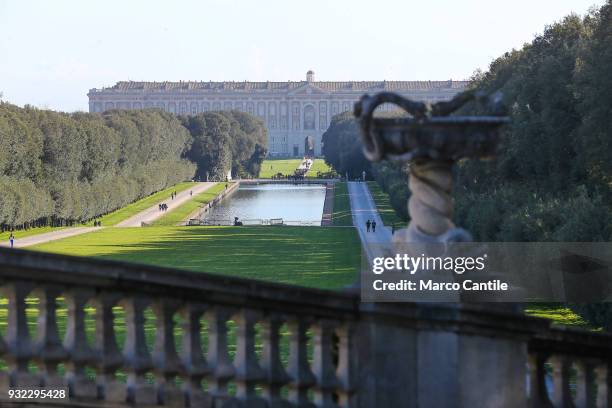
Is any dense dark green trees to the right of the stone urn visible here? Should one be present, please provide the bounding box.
[456,1,612,330]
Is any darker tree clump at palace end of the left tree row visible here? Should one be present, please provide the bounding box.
[181,111,267,180]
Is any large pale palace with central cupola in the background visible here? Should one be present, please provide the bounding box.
[87,71,467,156]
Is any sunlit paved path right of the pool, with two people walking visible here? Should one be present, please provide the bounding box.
[348,181,391,260]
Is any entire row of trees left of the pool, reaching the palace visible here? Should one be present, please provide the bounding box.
[0,103,266,230]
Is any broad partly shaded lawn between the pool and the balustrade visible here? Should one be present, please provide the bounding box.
[31,226,360,289]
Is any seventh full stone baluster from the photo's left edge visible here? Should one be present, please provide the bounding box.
[180,304,212,408]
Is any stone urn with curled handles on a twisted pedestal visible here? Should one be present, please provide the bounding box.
[354,90,509,243]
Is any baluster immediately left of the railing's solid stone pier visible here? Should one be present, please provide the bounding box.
[336,323,357,408]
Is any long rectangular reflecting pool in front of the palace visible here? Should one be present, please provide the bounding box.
[203,184,325,225]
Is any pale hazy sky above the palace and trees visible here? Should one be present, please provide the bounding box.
[0,0,604,112]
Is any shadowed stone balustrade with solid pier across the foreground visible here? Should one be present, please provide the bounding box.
[0,249,612,407]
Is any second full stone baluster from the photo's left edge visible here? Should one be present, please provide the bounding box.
[33,286,67,388]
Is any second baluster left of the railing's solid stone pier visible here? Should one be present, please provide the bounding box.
[312,320,340,408]
